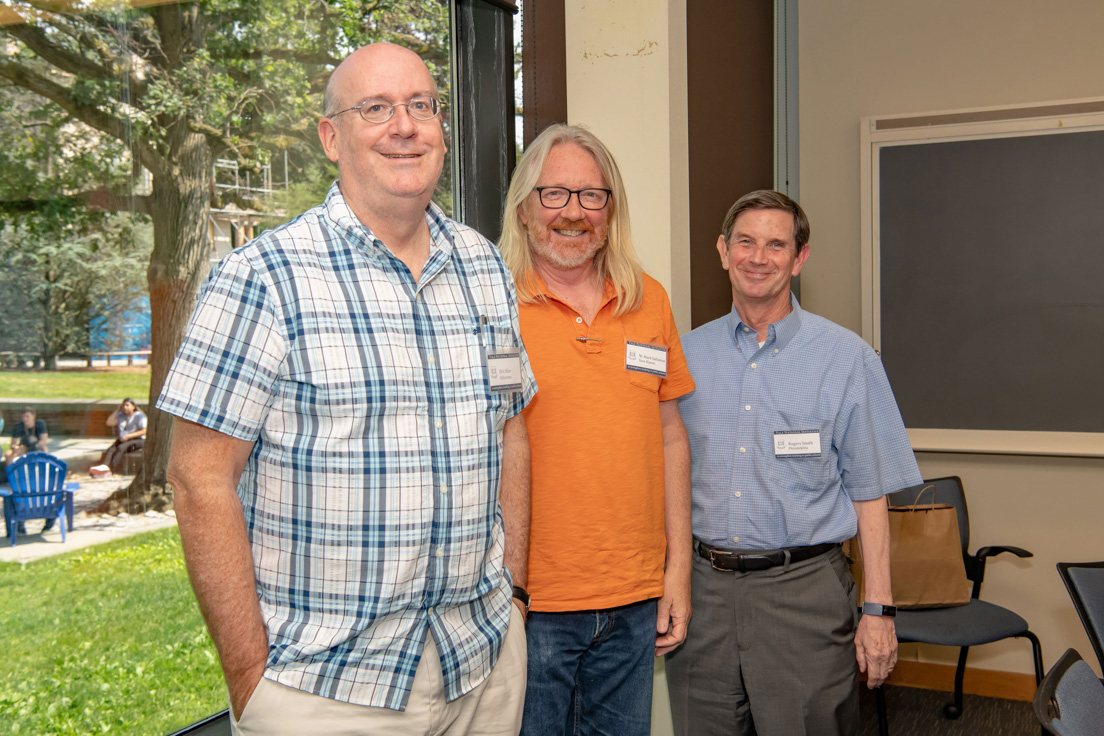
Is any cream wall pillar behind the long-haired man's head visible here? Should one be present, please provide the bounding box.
[564,0,690,331]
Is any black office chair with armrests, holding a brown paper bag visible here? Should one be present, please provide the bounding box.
[874,476,1043,736]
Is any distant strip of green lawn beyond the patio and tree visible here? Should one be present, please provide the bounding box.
[0,369,149,402]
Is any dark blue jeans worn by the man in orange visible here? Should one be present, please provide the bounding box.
[521,600,656,736]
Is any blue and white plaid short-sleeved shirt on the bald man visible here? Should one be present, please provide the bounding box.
[159,183,537,710]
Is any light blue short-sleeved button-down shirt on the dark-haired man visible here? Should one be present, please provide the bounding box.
[679,298,921,550]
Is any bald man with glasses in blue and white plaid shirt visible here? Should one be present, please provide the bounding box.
[159,44,537,734]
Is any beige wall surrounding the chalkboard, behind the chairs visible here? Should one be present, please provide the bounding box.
[798,0,1104,672]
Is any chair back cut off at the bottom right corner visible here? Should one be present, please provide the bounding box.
[1033,649,1104,736]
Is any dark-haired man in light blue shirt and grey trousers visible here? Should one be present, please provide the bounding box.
[667,191,921,736]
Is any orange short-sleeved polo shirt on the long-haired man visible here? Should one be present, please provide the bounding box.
[520,275,694,611]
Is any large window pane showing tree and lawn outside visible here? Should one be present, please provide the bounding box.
[0,0,456,734]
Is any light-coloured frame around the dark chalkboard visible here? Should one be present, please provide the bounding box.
[860,98,1104,457]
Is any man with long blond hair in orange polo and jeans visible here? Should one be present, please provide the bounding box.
[499,125,693,736]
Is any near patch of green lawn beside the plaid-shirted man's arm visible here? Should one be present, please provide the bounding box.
[0,527,226,735]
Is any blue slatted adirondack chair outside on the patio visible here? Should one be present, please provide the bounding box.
[3,452,73,546]
